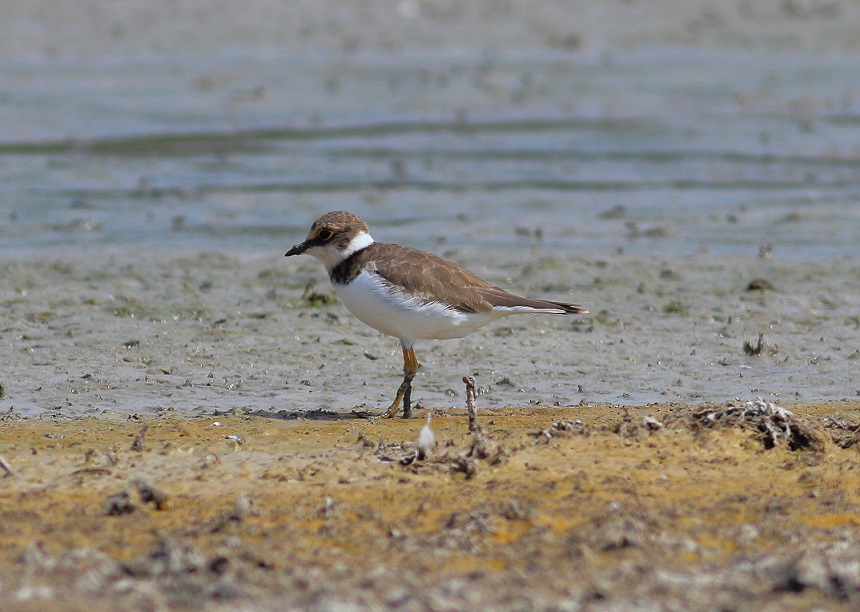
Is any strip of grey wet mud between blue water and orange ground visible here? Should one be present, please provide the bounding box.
[0,246,860,418]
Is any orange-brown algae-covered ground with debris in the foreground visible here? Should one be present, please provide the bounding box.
[0,402,860,610]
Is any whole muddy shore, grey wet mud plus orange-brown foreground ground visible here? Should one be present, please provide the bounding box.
[0,247,860,610]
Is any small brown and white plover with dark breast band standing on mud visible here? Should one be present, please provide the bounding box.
[286,210,588,419]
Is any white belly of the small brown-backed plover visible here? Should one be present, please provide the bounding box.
[335,272,506,340]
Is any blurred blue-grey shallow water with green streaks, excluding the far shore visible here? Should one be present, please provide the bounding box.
[0,51,860,259]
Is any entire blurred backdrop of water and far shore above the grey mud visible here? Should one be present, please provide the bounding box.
[0,0,860,259]
